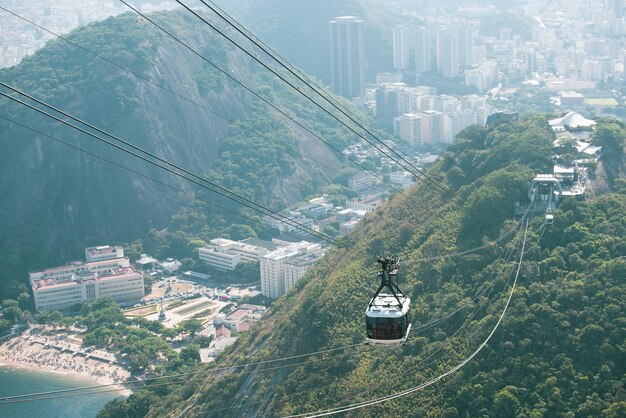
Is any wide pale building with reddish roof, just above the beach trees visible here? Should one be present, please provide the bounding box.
[29,248,145,311]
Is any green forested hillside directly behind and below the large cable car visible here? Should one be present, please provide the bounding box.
[96,118,626,417]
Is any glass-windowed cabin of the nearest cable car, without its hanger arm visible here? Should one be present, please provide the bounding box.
[365,293,411,345]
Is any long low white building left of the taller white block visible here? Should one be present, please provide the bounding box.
[198,238,269,271]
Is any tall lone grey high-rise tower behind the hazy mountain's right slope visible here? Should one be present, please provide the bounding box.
[329,16,365,98]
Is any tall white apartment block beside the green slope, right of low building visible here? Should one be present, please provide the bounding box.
[261,241,322,298]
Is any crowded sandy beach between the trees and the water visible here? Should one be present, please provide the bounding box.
[0,330,131,396]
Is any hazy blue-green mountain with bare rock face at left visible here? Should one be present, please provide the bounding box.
[0,12,352,297]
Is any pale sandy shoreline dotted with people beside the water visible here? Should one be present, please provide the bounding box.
[0,334,133,397]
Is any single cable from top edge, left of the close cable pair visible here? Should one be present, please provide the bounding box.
[119,0,404,198]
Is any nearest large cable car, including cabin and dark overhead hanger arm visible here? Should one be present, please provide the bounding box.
[365,257,411,345]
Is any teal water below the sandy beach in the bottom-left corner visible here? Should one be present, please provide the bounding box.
[0,366,122,418]
